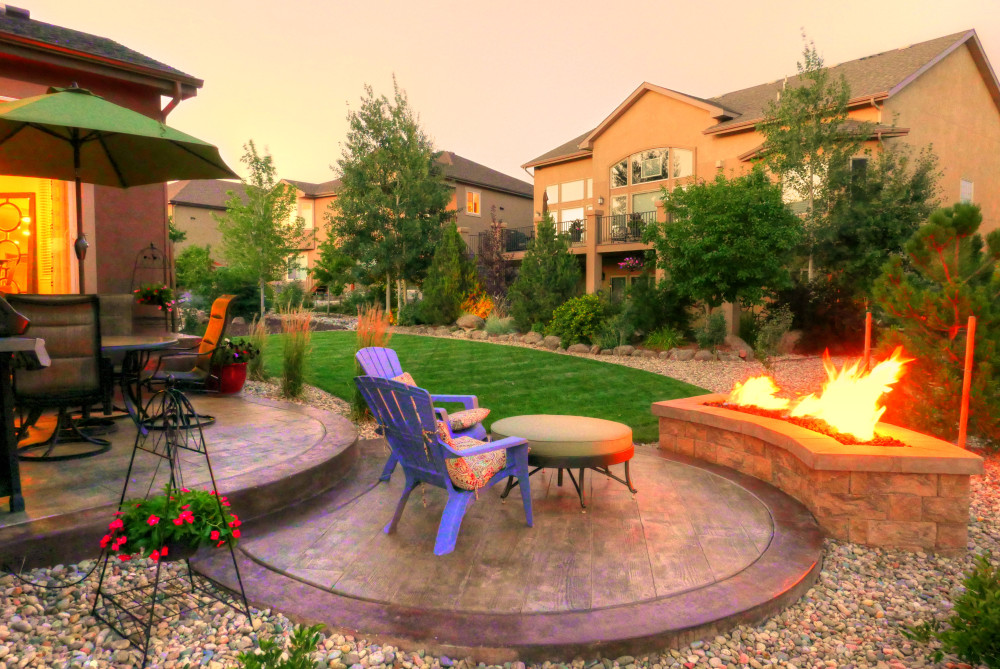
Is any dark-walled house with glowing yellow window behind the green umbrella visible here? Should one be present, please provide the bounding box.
[0,4,203,293]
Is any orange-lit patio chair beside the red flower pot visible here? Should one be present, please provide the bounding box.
[143,295,236,427]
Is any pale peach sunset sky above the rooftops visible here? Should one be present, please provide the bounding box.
[23,0,1000,182]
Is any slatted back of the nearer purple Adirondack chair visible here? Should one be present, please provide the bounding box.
[354,376,451,488]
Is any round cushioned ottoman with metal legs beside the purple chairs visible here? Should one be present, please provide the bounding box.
[491,414,636,508]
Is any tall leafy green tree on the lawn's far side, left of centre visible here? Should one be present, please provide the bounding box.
[326,79,455,311]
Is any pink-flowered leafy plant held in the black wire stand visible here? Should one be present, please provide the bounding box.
[101,486,242,562]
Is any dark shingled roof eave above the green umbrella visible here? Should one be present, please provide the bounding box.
[0,5,204,87]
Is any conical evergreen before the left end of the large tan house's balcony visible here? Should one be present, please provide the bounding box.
[507,214,580,330]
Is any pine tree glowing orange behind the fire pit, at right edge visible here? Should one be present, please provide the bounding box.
[875,204,1000,443]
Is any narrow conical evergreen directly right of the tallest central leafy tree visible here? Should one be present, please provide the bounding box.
[420,223,475,325]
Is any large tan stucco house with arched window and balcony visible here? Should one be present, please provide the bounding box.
[514,30,1000,292]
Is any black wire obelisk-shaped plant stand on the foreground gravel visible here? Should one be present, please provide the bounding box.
[92,385,251,667]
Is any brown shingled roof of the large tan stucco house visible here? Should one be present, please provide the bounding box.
[523,30,1000,167]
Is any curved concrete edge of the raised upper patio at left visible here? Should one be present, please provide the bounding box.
[0,397,358,570]
